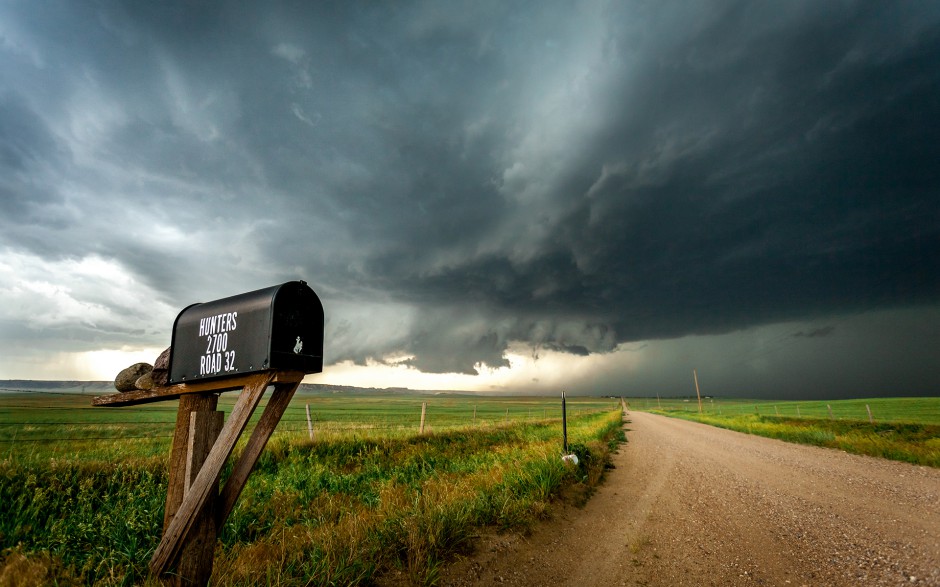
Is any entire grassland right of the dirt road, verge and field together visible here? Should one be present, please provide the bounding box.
[630,397,940,467]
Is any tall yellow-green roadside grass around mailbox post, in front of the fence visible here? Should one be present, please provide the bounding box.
[0,410,622,586]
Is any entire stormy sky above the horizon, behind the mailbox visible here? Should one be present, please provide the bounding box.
[0,0,940,398]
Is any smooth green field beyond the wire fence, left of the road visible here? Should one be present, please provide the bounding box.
[0,388,619,463]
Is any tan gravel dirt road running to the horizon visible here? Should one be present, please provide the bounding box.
[442,412,940,587]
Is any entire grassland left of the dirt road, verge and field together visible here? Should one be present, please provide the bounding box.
[0,393,622,585]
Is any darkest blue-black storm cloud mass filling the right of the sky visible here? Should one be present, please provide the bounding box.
[354,5,940,362]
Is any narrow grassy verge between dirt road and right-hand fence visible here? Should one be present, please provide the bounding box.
[658,411,940,467]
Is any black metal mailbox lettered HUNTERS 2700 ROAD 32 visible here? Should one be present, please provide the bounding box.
[170,281,323,383]
